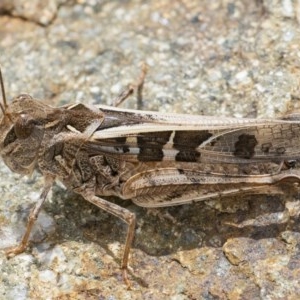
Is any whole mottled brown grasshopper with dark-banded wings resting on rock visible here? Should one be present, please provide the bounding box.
[0,65,300,285]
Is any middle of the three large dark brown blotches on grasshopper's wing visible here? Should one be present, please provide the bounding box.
[173,130,212,162]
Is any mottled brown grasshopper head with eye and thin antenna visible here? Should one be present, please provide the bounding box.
[0,70,49,175]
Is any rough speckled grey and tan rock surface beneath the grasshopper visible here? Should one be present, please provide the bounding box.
[0,0,300,300]
